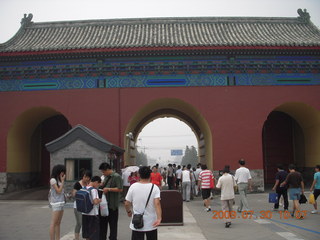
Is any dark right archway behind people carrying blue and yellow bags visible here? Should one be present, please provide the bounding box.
[262,102,320,184]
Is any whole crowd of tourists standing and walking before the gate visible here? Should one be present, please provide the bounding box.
[49,159,320,240]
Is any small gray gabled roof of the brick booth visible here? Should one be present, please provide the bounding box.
[46,125,125,154]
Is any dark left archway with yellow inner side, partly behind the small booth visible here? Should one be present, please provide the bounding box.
[7,107,70,191]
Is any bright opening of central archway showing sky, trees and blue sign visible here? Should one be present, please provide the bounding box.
[135,117,199,167]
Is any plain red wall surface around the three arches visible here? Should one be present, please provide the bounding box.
[0,86,320,172]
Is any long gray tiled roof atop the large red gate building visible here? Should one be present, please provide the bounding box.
[0,11,320,53]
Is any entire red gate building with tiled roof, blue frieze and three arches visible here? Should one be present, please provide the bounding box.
[0,9,320,192]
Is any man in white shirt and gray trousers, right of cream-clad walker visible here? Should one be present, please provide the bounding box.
[234,159,252,212]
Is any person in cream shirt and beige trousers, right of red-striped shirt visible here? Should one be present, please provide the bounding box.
[216,166,236,228]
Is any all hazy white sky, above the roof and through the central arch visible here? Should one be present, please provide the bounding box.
[0,0,320,165]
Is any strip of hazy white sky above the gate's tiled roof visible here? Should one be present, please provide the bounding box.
[0,0,320,43]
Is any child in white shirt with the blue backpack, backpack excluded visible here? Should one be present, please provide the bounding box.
[82,176,101,240]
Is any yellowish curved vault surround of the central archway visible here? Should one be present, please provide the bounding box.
[124,98,214,168]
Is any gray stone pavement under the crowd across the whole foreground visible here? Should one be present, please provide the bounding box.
[0,193,320,240]
